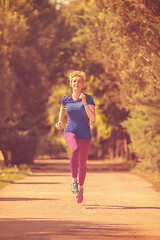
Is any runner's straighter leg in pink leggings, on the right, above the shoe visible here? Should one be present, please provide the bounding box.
[78,139,91,189]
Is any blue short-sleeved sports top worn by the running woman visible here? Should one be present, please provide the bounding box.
[61,94,95,139]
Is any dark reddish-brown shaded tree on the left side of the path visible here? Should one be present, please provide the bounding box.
[0,0,75,164]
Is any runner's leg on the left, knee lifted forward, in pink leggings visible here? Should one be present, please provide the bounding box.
[64,133,79,178]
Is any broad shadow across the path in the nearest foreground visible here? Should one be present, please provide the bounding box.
[0,219,159,240]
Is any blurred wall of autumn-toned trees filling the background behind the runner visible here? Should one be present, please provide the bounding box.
[0,0,160,170]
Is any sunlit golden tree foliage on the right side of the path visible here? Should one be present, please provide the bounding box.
[64,0,160,166]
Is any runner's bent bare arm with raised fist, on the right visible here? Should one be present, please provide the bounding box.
[80,93,96,122]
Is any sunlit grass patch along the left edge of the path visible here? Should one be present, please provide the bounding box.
[0,165,31,189]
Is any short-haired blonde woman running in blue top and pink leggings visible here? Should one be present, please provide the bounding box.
[56,71,95,203]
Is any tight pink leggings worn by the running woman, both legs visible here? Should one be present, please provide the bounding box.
[64,133,91,186]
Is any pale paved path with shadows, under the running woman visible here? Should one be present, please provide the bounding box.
[0,160,160,240]
